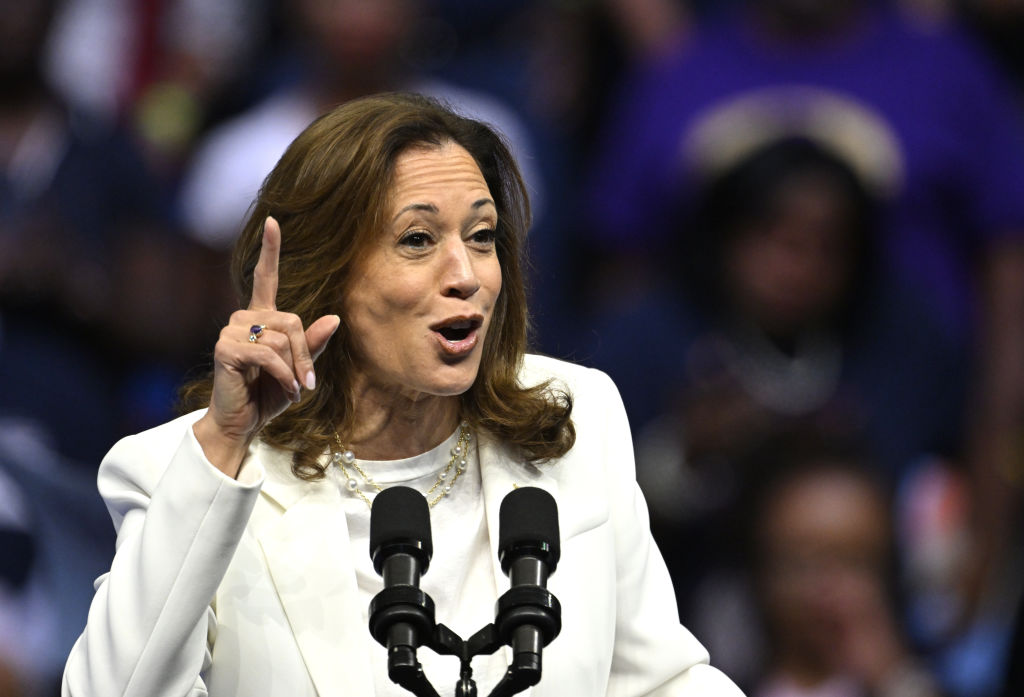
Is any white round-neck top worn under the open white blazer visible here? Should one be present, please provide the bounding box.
[331,429,506,697]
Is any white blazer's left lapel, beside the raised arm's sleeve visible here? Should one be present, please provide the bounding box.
[256,446,374,697]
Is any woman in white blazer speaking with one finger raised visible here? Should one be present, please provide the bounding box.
[63,95,735,697]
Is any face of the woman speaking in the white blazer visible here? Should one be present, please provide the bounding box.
[344,143,502,399]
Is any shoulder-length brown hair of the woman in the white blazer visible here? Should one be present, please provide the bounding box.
[181,93,575,479]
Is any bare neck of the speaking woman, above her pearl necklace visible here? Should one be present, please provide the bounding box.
[342,382,459,460]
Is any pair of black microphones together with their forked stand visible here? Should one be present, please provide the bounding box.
[370,487,562,697]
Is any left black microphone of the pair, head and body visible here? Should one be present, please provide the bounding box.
[370,486,434,684]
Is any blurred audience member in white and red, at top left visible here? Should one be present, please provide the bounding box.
[46,0,280,170]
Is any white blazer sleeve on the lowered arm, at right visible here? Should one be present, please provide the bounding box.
[595,372,742,697]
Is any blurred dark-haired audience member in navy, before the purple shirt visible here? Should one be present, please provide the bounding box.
[594,138,965,674]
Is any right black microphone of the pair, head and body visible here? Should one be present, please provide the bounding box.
[492,486,562,694]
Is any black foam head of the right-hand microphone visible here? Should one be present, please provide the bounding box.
[498,486,561,573]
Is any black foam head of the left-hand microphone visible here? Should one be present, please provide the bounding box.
[370,486,434,573]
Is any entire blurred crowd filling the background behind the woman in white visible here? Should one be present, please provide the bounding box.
[0,0,1024,697]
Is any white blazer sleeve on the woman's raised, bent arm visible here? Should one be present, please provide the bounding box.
[61,415,262,697]
